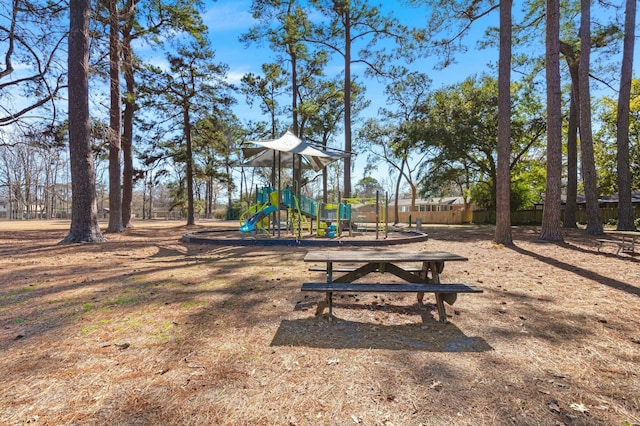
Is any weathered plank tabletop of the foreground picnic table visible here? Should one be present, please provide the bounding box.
[304,250,469,263]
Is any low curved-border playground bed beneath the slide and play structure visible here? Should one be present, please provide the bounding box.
[182,228,429,247]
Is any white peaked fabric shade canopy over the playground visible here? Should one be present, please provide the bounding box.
[242,131,349,172]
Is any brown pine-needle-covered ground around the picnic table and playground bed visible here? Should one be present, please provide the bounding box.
[0,221,640,426]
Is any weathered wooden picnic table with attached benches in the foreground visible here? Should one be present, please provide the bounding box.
[302,249,482,322]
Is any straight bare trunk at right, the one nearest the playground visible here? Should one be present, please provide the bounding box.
[494,0,513,244]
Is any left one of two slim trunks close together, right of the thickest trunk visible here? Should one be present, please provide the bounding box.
[107,0,124,232]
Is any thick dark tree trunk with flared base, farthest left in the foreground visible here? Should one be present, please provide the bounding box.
[62,0,105,243]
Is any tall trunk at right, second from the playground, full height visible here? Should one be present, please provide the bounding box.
[540,0,563,241]
